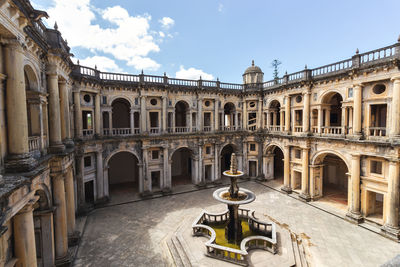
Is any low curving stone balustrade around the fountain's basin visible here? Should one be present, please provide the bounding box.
[192,209,277,266]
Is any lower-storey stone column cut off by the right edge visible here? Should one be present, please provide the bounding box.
[382,160,400,239]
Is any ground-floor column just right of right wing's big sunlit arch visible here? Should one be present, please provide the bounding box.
[346,154,362,223]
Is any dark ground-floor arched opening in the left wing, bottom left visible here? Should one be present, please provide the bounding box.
[33,190,54,266]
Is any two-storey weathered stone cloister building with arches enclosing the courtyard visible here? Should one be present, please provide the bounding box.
[0,0,400,266]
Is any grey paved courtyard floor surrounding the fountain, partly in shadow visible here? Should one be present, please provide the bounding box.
[74,182,400,267]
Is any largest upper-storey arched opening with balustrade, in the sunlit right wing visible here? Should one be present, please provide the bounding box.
[322,92,343,134]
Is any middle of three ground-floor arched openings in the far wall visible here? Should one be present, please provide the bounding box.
[171,147,193,186]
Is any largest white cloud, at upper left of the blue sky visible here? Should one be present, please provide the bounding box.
[40,0,166,70]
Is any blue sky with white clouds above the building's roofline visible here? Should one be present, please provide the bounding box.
[31,0,400,83]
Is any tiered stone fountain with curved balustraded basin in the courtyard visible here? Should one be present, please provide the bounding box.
[192,153,277,266]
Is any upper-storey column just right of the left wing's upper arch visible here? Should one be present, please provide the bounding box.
[47,70,65,153]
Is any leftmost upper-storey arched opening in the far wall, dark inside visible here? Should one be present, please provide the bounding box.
[111,98,131,129]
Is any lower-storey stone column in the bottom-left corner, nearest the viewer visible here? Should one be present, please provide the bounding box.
[13,201,37,267]
